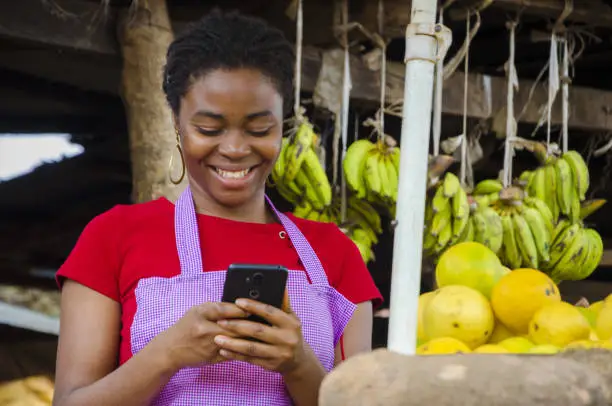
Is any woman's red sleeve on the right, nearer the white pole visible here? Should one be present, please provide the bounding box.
[333,225,383,308]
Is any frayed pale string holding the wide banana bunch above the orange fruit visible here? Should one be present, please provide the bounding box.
[502,21,518,187]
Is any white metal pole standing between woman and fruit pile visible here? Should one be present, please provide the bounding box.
[387,0,444,355]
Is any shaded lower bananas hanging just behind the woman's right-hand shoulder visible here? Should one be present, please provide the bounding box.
[293,196,383,263]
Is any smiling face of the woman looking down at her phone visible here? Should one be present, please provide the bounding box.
[176,69,283,208]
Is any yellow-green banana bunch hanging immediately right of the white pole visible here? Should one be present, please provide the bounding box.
[423,172,474,255]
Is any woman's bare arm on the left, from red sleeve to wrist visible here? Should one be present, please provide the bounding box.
[53,280,175,406]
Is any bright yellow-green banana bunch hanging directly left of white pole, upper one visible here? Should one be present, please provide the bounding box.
[342,139,400,205]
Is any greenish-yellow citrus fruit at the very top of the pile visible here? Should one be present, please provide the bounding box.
[436,242,506,298]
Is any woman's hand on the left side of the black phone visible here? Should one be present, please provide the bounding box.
[149,302,247,370]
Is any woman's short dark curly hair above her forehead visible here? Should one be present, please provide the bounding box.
[163,9,295,114]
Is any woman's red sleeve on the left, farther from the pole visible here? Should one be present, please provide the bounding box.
[56,206,121,301]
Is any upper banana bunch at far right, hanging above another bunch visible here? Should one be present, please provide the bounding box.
[521,151,590,222]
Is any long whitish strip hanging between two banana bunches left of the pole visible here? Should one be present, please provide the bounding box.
[334,0,351,222]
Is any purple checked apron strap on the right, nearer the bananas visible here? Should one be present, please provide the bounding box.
[266,195,329,285]
